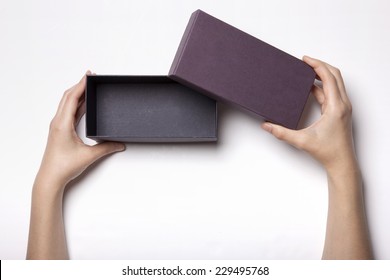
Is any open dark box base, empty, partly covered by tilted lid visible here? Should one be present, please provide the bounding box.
[86,76,217,142]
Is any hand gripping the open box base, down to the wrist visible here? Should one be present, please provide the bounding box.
[37,71,125,188]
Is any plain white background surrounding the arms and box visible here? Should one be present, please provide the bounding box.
[0,0,390,259]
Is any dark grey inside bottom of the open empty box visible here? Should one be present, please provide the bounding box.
[96,82,216,138]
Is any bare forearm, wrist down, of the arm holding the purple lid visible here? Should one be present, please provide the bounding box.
[322,156,373,259]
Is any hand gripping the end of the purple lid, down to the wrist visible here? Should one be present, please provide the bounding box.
[262,56,356,171]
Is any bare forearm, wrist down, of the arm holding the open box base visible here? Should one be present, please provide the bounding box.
[26,174,69,259]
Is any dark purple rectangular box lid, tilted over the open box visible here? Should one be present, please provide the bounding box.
[169,10,315,129]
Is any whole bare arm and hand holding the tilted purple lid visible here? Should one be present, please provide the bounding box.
[263,57,373,259]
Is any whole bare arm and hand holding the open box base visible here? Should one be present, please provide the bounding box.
[26,72,125,259]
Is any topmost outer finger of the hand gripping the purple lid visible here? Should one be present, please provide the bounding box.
[303,56,342,104]
